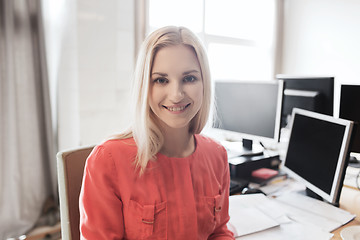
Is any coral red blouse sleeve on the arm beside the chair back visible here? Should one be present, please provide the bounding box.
[79,146,124,240]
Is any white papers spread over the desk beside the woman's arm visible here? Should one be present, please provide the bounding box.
[228,193,354,240]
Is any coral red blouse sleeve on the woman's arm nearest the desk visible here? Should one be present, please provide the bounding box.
[208,148,235,240]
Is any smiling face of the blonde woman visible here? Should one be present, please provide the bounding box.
[149,45,203,129]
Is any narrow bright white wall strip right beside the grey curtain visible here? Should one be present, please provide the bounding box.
[42,0,80,149]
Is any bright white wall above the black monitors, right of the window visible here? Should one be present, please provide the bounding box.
[281,0,360,114]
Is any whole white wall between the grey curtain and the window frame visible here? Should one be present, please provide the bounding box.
[43,0,135,150]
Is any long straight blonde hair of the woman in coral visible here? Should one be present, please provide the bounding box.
[117,26,212,174]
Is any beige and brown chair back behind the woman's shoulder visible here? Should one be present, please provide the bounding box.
[56,146,94,240]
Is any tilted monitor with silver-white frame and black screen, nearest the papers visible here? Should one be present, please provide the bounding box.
[282,108,353,205]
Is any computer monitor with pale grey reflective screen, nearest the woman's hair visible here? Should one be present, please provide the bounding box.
[214,81,283,155]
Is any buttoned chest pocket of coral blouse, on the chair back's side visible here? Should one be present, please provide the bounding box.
[124,200,167,239]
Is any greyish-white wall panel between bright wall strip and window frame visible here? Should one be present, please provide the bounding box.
[78,0,135,145]
